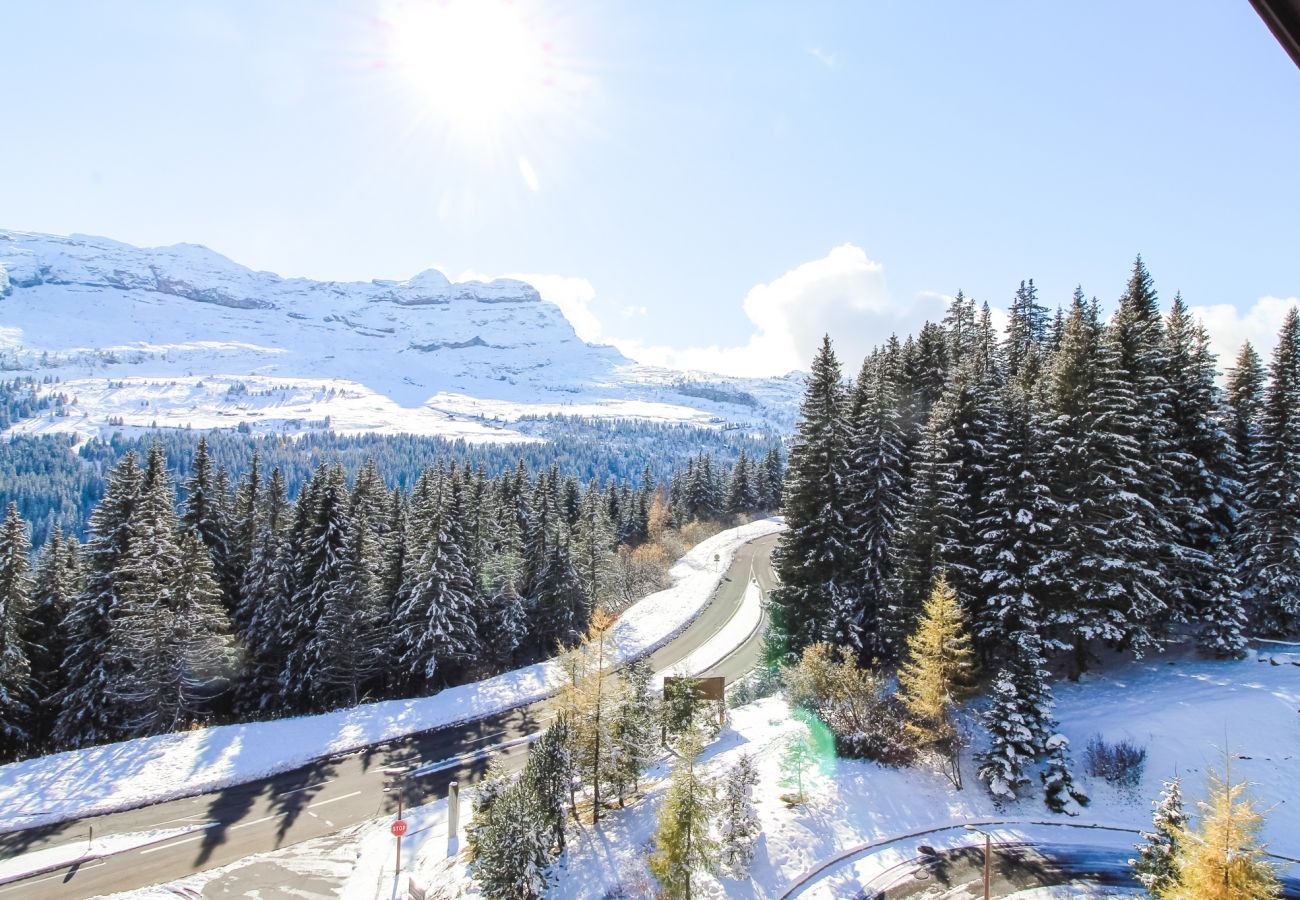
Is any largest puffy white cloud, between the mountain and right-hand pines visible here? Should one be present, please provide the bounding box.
[611,243,945,377]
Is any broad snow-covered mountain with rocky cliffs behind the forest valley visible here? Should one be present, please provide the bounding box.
[0,230,802,441]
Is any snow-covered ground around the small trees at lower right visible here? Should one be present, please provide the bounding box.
[403,654,1300,897]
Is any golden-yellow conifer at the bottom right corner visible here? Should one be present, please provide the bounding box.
[1158,771,1282,900]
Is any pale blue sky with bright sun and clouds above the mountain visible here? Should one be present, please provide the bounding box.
[0,0,1300,376]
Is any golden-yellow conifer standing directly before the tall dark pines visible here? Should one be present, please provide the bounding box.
[898,576,975,788]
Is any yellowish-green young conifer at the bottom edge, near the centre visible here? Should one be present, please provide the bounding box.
[649,732,719,900]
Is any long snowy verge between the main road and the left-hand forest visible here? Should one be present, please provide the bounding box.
[0,519,783,832]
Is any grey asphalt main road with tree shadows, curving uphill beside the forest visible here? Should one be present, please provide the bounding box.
[0,528,776,900]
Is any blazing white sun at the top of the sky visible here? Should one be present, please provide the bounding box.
[386,0,554,137]
